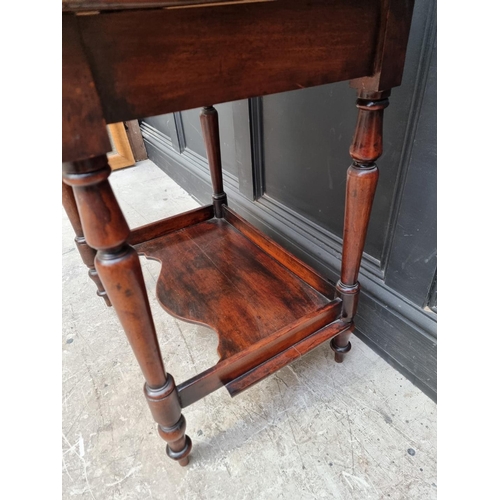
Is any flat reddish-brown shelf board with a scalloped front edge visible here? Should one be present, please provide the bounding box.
[137,219,328,359]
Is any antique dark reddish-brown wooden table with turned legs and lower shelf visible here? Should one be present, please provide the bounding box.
[63,0,413,465]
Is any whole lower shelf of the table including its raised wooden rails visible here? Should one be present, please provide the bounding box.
[132,207,351,406]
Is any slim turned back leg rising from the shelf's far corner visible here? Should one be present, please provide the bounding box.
[200,106,227,218]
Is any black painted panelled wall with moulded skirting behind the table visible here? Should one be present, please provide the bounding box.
[141,0,437,399]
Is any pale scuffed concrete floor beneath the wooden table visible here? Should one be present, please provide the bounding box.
[62,161,437,500]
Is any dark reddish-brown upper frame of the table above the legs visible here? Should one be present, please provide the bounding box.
[63,0,413,161]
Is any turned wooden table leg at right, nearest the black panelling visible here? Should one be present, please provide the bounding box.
[330,91,390,363]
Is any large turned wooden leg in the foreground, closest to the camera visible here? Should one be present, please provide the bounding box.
[63,156,191,465]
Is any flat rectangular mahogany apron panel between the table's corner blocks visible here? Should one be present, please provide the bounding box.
[78,0,380,123]
